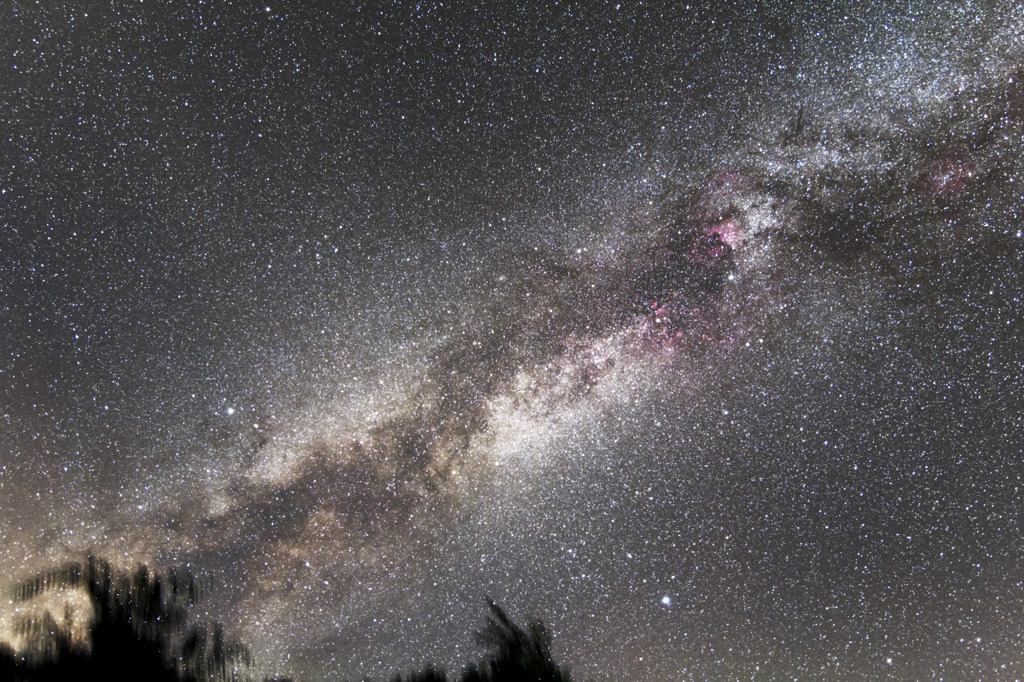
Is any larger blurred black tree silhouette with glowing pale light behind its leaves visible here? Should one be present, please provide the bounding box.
[0,557,251,682]
